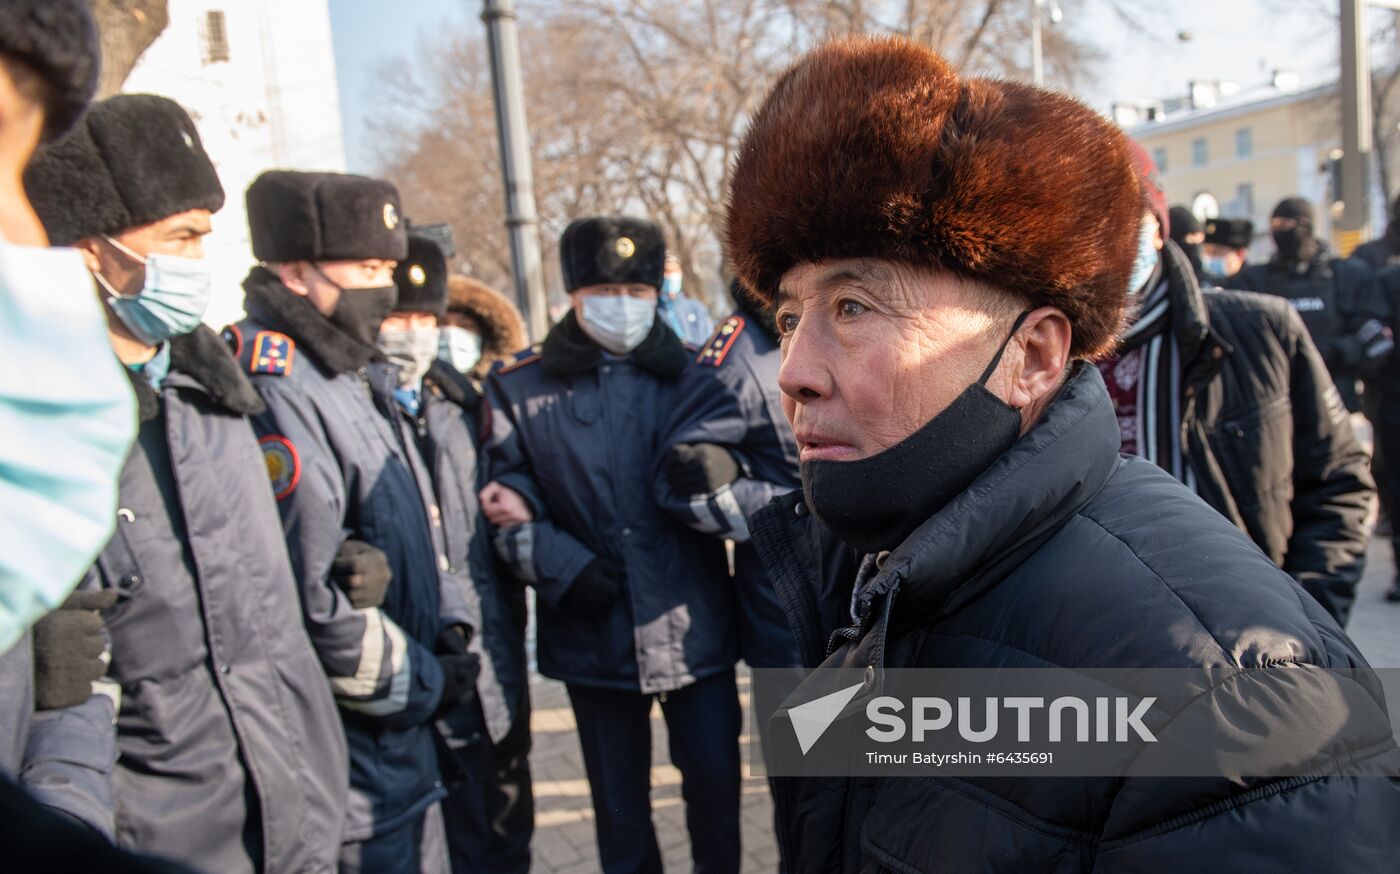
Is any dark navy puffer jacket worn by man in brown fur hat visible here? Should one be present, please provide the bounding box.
[750,366,1400,874]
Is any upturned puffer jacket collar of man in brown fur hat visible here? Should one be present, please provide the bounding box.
[855,361,1120,641]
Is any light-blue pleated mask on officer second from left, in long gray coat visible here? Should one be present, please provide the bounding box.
[94,237,214,346]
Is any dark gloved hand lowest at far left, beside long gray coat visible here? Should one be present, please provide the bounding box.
[34,588,116,710]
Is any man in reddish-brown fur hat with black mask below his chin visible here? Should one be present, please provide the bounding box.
[728,39,1400,873]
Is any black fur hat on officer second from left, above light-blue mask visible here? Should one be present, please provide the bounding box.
[24,94,224,245]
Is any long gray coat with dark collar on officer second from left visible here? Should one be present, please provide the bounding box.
[31,328,347,873]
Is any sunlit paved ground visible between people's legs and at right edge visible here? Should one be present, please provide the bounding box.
[531,538,1400,874]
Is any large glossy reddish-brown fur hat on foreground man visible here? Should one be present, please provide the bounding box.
[727,38,1142,357]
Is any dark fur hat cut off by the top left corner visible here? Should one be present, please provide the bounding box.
[0,0,102,140]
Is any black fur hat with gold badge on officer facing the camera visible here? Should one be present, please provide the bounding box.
[559,216,666,291]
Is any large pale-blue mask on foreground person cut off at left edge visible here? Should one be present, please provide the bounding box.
[0,240,136,653]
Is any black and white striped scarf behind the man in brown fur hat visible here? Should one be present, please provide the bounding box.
[1119,277,1196,492]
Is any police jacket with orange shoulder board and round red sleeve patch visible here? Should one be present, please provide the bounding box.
[224,268,444,842]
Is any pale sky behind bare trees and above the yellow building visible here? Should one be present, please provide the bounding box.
[329,0,1337,172]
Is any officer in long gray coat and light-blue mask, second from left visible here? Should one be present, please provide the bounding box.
[25,95,347,873]
